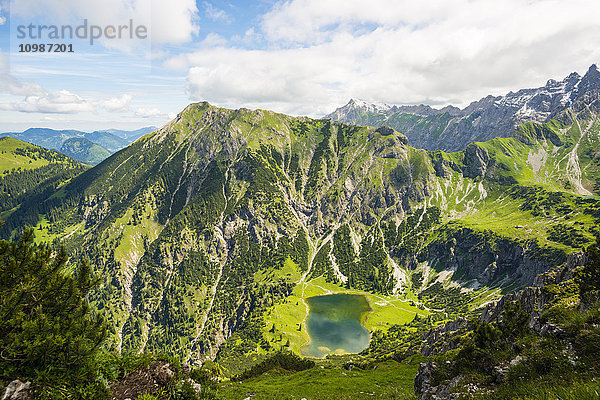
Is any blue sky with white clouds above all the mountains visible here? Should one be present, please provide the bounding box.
[0,0,600,132]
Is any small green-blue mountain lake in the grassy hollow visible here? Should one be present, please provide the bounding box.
[302,294,371,358]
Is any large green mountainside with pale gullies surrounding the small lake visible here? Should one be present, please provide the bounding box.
[3,95,600,374]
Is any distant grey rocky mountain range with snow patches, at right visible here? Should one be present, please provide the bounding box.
[325,64,600,151]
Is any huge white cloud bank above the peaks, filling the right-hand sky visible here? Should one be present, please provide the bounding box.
[171,0,600,115]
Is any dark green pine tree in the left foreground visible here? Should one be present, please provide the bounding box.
[0,228,107,386]
